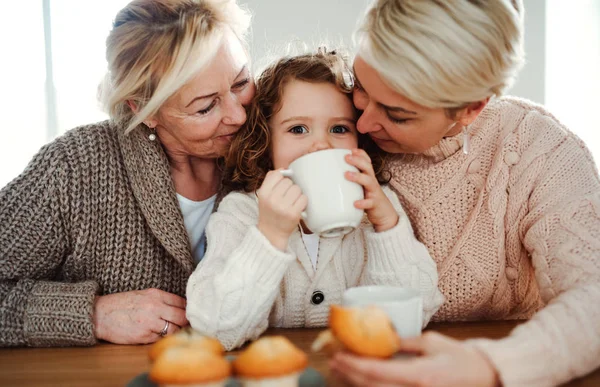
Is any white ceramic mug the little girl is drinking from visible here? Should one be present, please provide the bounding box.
[281,149,364,237]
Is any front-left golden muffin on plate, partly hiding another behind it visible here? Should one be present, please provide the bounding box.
[149,346,231,387]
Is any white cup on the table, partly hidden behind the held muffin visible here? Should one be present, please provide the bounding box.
[342,286,423,337]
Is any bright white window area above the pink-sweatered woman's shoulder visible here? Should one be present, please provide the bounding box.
[545,0,600,161]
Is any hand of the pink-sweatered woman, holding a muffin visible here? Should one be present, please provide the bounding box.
[330,332,500,387]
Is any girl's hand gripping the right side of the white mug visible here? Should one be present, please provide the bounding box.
[346,149,398,232]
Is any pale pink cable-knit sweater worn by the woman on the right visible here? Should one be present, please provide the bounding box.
[391,98,600,386]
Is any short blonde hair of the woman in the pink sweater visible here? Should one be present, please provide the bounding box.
[355,0,523,109]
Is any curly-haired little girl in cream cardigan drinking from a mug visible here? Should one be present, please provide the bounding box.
[187,50,443,350]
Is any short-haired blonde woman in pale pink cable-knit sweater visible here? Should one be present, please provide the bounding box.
[332,0,600,386]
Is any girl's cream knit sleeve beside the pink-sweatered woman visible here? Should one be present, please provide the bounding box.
[360,186,444,327]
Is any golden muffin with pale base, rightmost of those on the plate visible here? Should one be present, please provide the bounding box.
[233,336,308,387]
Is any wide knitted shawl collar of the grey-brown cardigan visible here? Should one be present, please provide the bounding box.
[115,125,194,273]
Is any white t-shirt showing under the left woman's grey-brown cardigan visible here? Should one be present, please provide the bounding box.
[177,194,217,263]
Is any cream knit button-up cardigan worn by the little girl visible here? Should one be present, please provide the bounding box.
[187,187,443,350]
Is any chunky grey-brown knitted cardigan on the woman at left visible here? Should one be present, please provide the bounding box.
[0,121,194,346]
